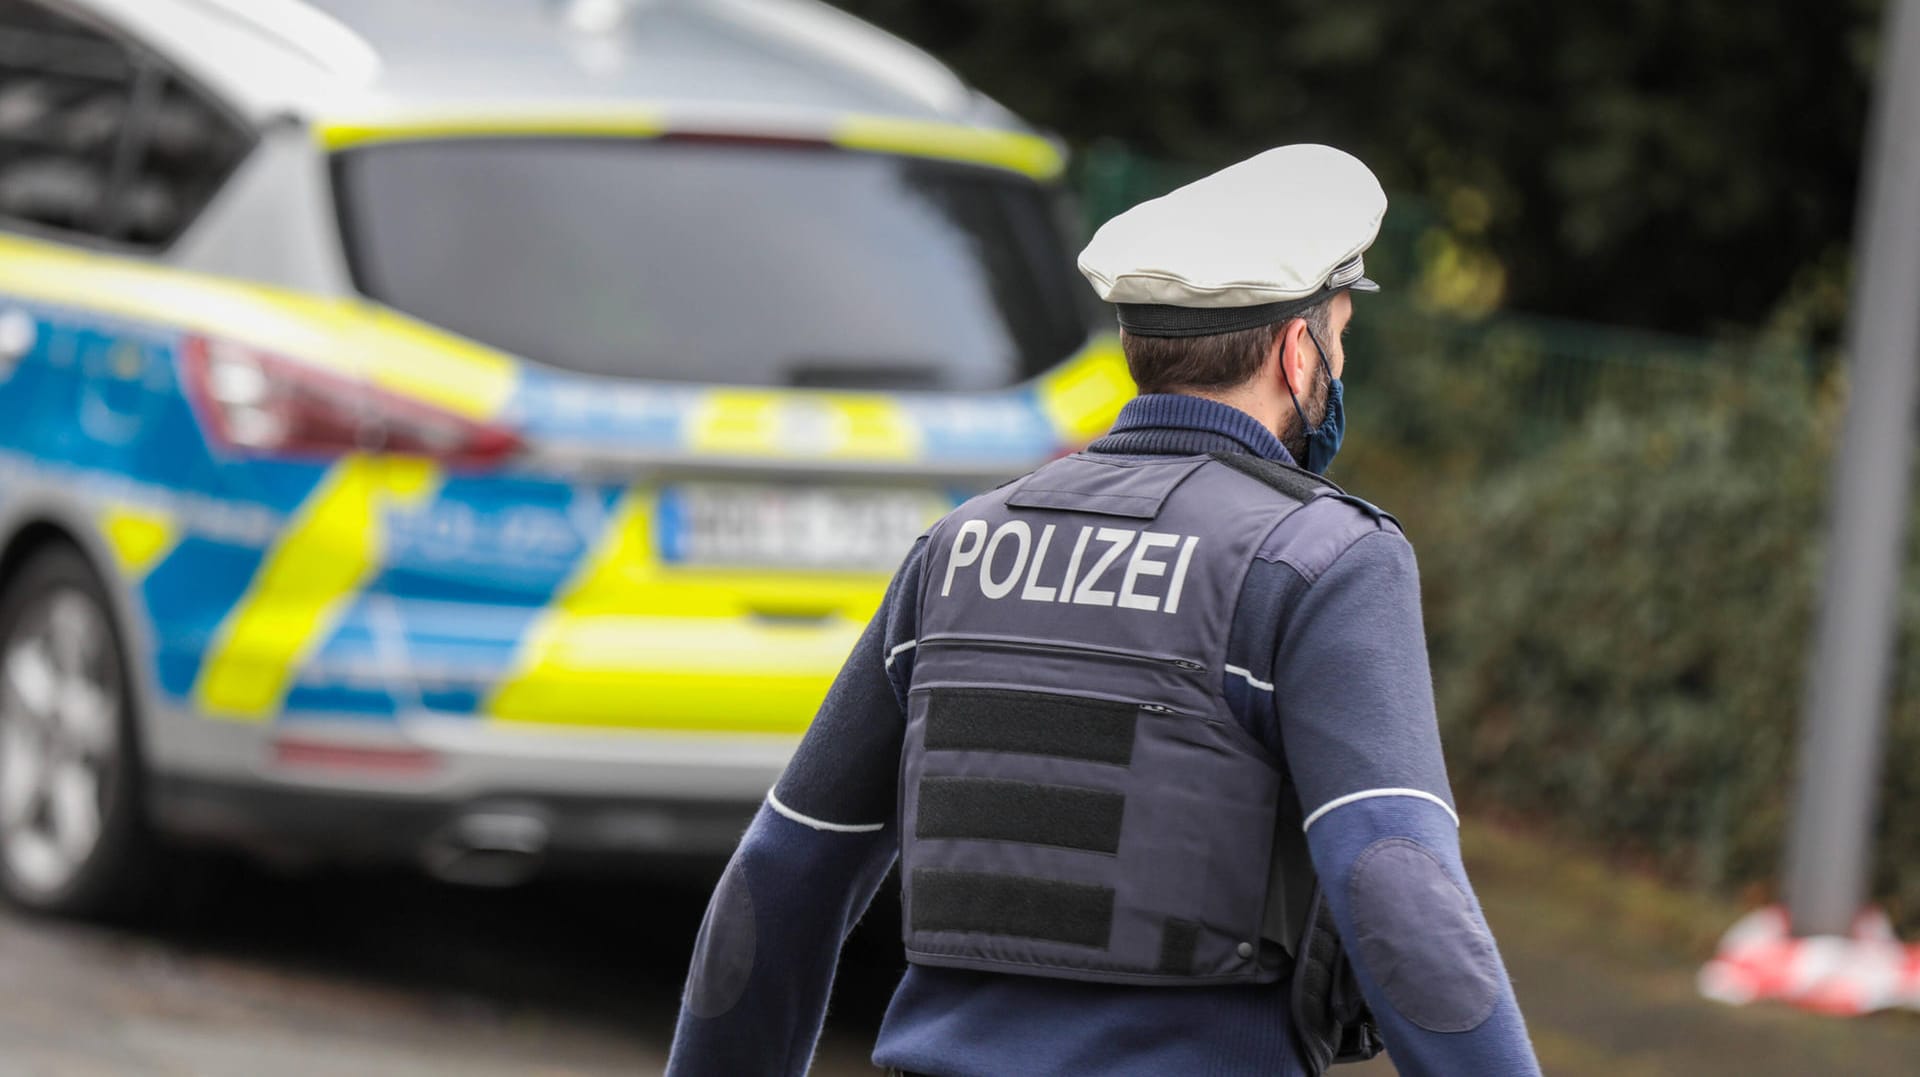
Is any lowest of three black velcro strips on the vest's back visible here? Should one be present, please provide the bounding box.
[910,868,1114,950]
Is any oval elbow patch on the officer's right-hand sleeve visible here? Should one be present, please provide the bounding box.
[1348,837,1503,1033]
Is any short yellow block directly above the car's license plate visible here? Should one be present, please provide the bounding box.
[687,390,920,461]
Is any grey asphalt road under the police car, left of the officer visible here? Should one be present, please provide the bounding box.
[0,866,895,1077]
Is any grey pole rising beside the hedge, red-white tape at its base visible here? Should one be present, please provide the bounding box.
[1786,0,1920,935]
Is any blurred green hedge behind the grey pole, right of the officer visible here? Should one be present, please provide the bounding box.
[1338,351,1920,929]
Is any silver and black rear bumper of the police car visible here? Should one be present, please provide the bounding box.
[148,712,795,881]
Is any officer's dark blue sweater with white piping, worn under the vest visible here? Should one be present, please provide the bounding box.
[668,395,1540,1077]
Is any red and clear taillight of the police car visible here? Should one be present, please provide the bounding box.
[184,336,520,467]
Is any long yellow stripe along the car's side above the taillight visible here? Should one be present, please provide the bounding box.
[0,236,520,420]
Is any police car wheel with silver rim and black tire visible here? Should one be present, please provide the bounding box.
[0,545,156,918]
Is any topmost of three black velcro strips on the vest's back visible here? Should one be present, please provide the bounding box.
[925,687,1140,766]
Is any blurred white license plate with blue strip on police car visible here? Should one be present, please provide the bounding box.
[657,482,956,572]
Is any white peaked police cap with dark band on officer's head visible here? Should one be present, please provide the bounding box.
[1079,144,1386,336]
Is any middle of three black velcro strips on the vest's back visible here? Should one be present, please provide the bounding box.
[914,778,1127,852]
